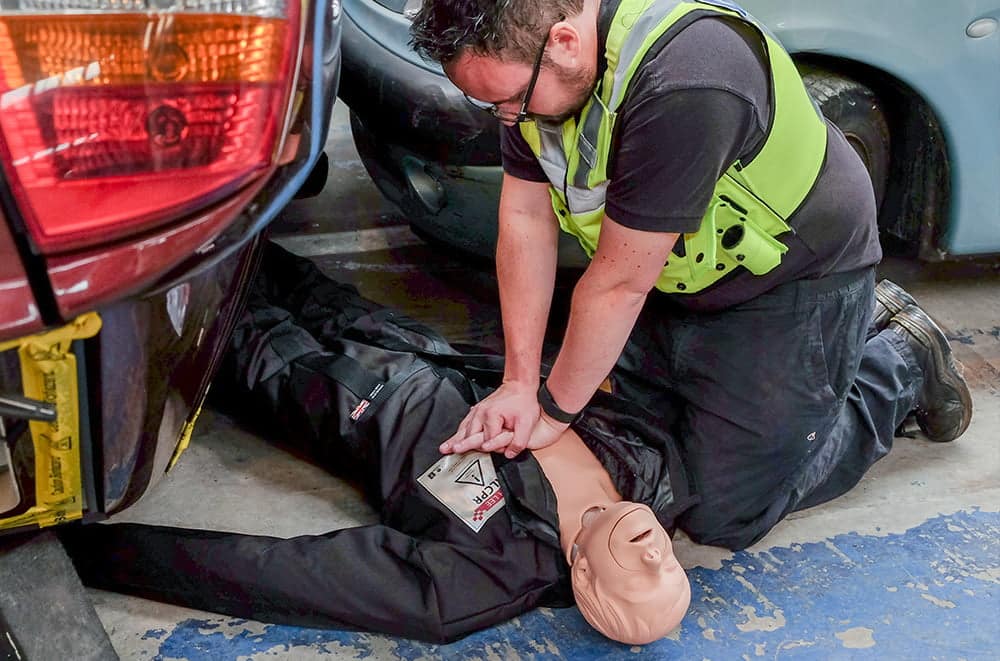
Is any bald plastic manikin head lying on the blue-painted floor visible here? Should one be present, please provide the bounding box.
[570,501,691,645]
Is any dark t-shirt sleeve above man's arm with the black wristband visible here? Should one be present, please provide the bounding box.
[605,88,759,233]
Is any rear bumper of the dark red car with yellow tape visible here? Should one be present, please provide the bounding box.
[0,239,259,534]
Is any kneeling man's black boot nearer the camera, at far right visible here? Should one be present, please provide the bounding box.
[887,305,972,443]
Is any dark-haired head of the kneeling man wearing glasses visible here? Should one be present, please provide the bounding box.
[410,0,599,125]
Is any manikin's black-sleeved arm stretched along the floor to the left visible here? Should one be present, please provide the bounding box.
[61,517,562,643]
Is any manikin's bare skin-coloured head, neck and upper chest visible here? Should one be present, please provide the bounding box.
[534,430,691,645]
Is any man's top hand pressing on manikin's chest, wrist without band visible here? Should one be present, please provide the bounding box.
[439,381,541,457]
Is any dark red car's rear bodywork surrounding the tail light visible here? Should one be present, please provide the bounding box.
[0,0,340,534]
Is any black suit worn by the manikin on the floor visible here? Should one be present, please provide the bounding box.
[56,247,693,642]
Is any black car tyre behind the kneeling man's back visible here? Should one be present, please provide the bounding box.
[802,68,892,209]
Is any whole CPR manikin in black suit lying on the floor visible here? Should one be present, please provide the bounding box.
[60,244,697,644]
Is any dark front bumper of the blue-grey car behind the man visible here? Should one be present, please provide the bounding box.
[339,0,587,268]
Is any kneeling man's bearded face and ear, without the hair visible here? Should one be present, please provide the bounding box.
[444,21,597,126]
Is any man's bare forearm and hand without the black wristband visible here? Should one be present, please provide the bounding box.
[441,174,559,452]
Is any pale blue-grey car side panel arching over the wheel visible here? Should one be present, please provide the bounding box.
[742,0,1000,256]
